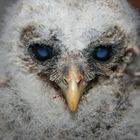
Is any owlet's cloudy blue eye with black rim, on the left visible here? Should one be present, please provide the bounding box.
[29,43,52,62]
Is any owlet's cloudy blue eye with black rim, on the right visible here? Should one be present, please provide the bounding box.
[93,46,112,61]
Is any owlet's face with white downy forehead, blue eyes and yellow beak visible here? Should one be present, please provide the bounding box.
[10,1,138,112]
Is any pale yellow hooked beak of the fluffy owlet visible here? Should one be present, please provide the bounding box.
[64,66,83,112]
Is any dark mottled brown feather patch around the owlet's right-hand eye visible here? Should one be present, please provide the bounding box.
[83,26,132,76]
